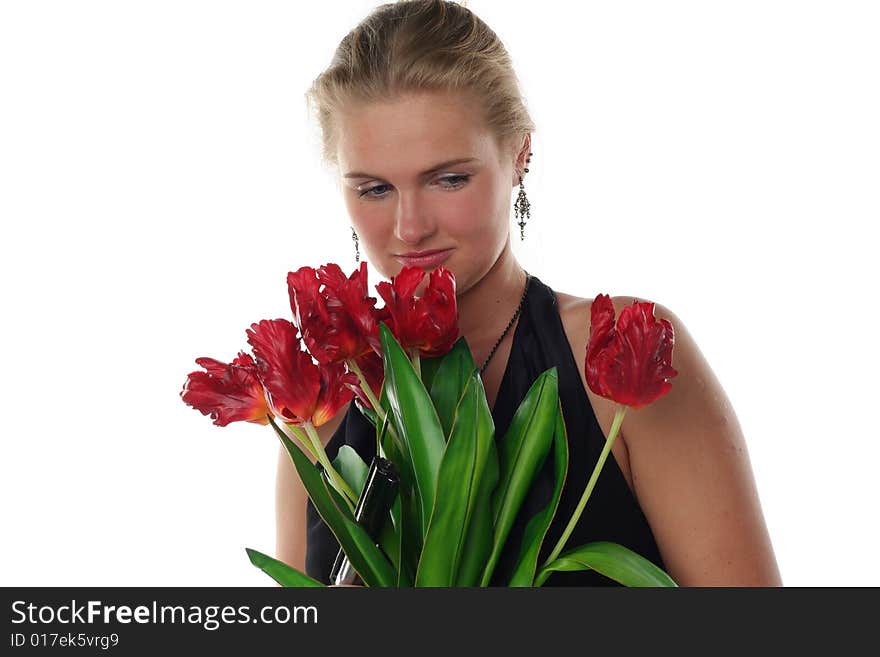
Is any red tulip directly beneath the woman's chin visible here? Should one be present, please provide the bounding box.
[376,265,458,357]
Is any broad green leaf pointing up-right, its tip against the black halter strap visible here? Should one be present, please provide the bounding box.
[480,367,559,586]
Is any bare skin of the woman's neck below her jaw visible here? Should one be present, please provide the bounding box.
[456,238,526,362]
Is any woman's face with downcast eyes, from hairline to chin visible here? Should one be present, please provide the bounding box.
[337,92,519,294]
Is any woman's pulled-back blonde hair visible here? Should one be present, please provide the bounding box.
[306,0,535,167]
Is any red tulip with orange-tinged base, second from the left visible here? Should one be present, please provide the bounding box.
[247,319,354,427]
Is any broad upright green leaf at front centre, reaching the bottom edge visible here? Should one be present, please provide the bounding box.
[416,368,495,586]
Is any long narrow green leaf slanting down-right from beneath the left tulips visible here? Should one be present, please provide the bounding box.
[270,421,396,586]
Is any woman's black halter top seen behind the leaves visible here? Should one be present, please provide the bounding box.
[306,275,665,586]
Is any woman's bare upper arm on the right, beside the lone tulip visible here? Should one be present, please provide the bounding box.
[614,297,782,586]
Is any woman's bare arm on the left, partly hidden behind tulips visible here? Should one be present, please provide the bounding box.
[275,405,348,573]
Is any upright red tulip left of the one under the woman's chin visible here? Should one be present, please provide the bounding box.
[287,262,381,364]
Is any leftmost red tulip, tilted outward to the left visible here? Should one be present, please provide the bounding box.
[180,351,269,427]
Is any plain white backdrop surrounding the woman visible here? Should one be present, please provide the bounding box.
[0,0,880,586]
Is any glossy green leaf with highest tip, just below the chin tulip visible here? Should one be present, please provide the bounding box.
[379,322,446,537]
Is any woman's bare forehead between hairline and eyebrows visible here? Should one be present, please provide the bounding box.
[336,92,497,176]
